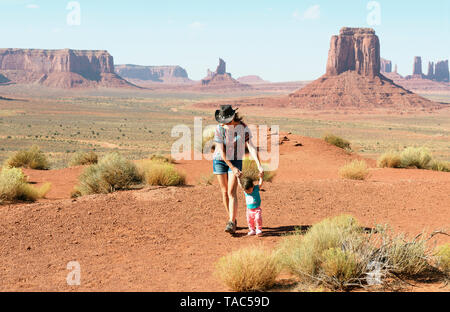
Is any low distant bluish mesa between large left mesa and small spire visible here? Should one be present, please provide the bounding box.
[115,64,192,84]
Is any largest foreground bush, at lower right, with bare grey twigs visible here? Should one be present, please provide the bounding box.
[278,216,442,290]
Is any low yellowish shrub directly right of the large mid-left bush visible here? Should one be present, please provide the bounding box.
[138,160,186,186]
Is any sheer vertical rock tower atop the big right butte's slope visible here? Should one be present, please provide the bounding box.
[327,27,381,77]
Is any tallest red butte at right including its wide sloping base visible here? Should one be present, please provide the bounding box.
[289,27,439,110]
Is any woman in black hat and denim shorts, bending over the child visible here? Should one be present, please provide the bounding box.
[213,105,264,234]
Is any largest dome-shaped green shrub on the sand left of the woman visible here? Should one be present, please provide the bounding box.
[73,153,142,195]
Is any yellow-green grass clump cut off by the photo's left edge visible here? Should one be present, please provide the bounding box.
[0,167,51,204]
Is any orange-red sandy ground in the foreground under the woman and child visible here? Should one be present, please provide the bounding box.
[0,135,450,291]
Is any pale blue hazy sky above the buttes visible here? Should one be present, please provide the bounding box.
[0,0,450,81]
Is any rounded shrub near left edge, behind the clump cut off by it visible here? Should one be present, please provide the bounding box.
[5,145,50,170]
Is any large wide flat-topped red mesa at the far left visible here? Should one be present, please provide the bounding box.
[0,49,135,88]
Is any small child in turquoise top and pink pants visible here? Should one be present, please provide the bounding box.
[238,177,263,236]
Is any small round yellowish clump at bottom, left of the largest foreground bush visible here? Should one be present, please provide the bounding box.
[215,246,280,292]
